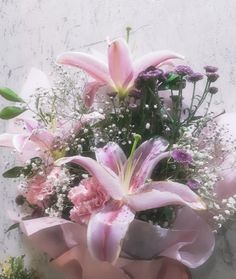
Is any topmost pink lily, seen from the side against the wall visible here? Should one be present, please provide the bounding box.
[57,38,183,106]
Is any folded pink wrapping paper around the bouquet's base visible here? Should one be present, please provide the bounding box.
[18,208,214,279]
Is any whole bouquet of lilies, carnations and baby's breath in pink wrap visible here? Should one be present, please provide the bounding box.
[0,34,236,279]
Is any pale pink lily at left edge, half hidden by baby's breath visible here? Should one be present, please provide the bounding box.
[0,112,103,162]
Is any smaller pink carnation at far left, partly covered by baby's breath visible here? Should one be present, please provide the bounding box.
[25,168,60,206]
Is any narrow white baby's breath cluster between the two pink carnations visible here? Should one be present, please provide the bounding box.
[45,168,73,217]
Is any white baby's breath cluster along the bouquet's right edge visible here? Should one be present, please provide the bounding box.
[174,119,236,231]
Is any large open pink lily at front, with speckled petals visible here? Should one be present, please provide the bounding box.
[56,139,206,262]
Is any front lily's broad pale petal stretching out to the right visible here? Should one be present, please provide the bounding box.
[126,181,206,211]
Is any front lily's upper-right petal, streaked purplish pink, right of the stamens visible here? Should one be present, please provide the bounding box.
[126,138,169,191]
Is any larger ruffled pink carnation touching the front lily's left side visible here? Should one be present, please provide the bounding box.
[68,178,110,223]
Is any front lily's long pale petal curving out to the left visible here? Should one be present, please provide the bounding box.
[55,156,123,200]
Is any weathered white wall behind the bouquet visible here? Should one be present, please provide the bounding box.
[0,0,236,279]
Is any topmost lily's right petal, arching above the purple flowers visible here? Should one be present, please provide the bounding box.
[134,50,184,79]
